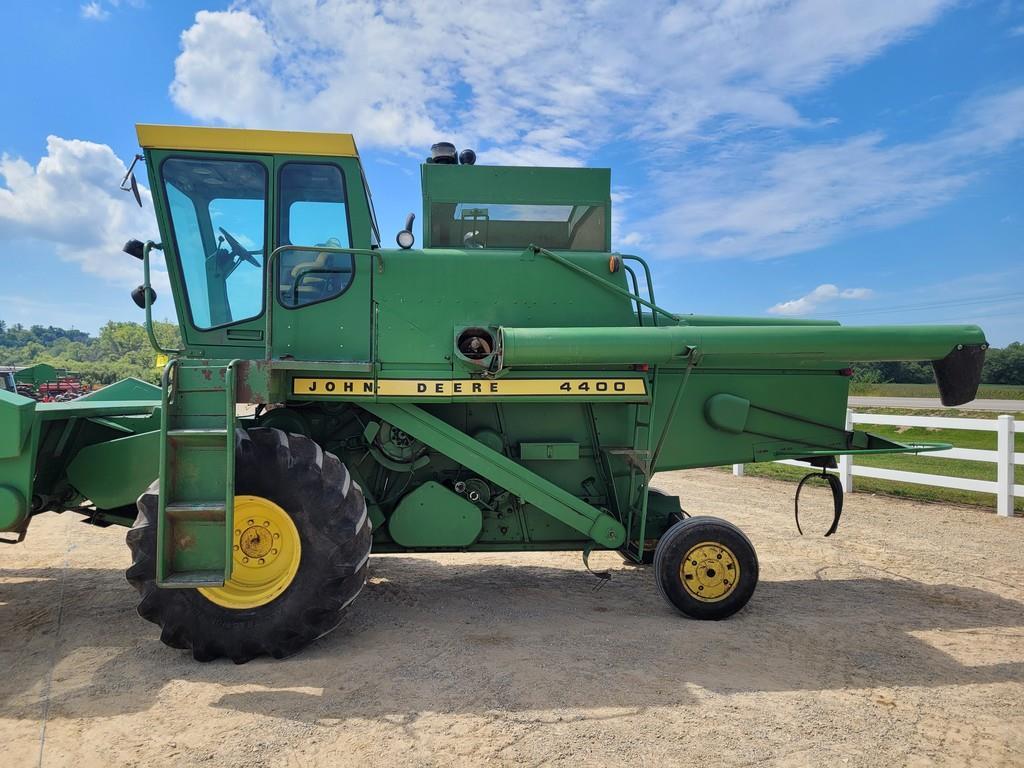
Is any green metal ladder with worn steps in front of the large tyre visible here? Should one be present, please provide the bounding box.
[156,359,238,587]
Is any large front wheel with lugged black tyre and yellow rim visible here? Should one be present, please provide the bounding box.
[126,428,371,664]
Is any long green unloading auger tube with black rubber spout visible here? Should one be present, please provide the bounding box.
[499,325,988,406]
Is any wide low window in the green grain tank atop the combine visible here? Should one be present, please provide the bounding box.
[430,203,607,251]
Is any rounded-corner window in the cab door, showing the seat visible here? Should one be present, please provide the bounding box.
[278,163,354,307]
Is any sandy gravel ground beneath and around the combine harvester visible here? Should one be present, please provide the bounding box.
[0,470,1024,768]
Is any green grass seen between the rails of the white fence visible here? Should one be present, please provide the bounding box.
[746,411,1024,512]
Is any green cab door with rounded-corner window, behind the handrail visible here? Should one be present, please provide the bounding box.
[270,157,373,362]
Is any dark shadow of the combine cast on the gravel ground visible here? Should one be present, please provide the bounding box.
[0,556,1024,722]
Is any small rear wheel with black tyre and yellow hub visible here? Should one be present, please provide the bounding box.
[654,517,758,620]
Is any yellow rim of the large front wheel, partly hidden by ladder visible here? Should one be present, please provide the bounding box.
[199,496,302,610]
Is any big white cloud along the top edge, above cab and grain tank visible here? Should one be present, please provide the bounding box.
[171,0,950,165]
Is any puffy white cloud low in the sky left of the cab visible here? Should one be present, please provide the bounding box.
[0,136,166,287]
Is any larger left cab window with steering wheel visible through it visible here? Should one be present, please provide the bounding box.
[161,158,266,330]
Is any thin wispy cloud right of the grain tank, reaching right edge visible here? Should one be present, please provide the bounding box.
[638,88,1024,258]
